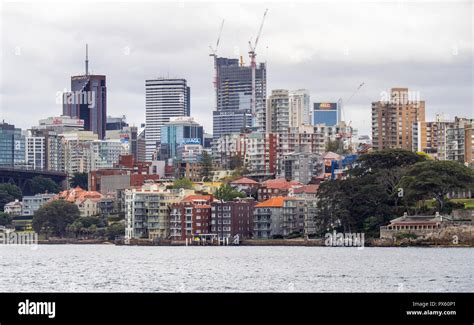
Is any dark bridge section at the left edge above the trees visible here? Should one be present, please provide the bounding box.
[0,166,67,195]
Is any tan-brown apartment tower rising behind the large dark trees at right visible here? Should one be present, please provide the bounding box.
[372,88,425,150]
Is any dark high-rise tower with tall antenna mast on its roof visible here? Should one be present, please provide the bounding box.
[63,45,107,139]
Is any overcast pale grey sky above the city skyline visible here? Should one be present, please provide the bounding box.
[0,1,474,134]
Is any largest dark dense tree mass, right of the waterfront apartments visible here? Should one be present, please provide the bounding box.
[318,149,436,236]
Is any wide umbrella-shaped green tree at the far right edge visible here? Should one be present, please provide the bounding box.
[401,160,474,211]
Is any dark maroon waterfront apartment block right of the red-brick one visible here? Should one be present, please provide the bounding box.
[211,199,255,239]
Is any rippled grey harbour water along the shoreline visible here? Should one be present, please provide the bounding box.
[0,245,474,292]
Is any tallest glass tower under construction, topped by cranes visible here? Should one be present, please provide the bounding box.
[213,58,267,139]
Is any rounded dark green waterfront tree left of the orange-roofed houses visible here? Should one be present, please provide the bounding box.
[32,200,80,237]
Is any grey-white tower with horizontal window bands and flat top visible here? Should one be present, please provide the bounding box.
[145,78,191,161]
